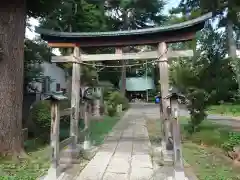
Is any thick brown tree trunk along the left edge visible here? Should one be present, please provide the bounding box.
[0,0,26,155]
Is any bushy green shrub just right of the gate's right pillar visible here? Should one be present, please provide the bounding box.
[171,57,208,133]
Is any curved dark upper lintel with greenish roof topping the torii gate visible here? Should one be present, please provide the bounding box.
[36,13,212,47]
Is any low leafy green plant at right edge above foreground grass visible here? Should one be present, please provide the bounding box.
[222,132,240,151]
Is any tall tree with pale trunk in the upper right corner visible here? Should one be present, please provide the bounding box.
[173,0,240,91]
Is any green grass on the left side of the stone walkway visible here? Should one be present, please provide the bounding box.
[0,116,120,180]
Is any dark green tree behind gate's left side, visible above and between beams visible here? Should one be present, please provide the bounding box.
[40,0,106,86]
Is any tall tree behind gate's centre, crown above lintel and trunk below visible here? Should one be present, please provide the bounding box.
[105,0,165,95]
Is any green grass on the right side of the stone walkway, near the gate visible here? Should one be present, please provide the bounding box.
[147,118,240,180]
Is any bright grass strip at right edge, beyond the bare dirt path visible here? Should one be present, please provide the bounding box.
[208,104,240,116]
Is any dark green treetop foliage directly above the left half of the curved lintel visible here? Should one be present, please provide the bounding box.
[40,0,106,32]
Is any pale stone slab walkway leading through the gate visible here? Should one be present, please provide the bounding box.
[76,109,153,180]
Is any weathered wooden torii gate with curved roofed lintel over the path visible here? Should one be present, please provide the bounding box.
[36,13,212,178]
